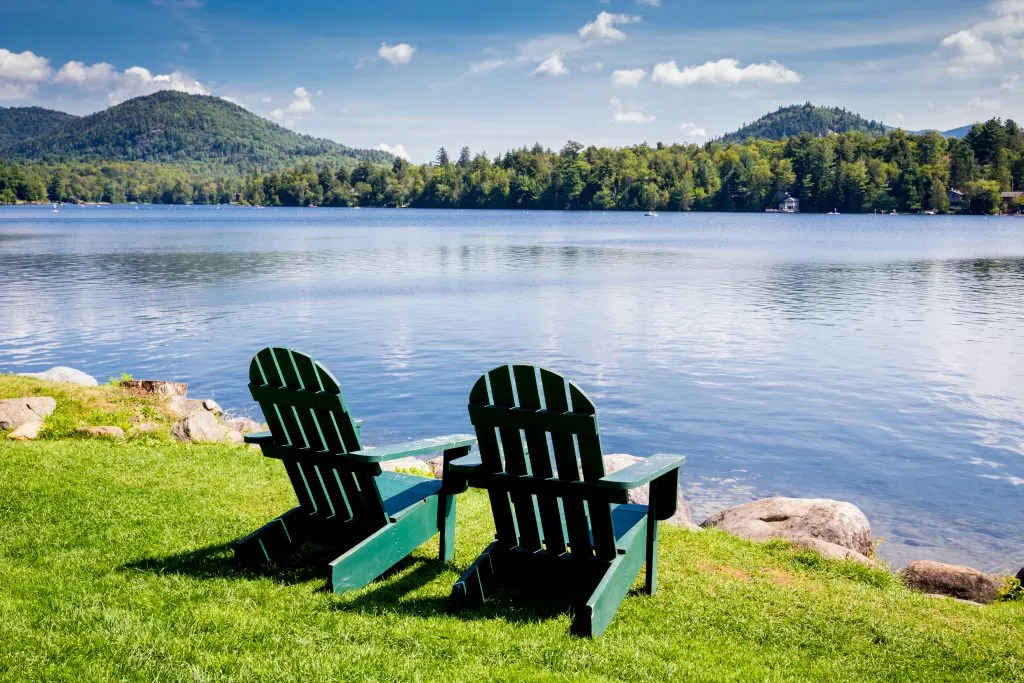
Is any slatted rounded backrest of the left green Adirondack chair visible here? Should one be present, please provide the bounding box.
[249,347,387,528]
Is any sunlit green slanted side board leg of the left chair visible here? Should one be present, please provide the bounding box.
[330,498,437,593]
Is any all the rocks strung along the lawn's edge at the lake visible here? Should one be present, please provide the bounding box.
[0,367,1024,605]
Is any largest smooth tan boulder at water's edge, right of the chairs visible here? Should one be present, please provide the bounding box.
[700,498,871,556]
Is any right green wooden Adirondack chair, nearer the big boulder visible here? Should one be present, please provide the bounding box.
[447,366,685,637]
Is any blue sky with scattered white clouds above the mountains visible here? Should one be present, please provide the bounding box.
[0,0,1024,162]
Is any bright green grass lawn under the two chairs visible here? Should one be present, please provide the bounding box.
[0,439,1024,681]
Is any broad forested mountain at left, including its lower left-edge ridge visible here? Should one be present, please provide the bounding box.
[0,91,393,173]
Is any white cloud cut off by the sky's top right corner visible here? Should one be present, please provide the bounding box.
[941,0,1024,74]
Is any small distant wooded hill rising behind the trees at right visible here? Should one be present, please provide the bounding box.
[722,102,886,142]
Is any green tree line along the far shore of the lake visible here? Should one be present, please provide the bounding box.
[0,119,1024,213]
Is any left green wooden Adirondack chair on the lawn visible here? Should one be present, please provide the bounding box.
[234,347,476,593]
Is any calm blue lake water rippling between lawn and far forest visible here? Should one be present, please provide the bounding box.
[0,207,1024,572]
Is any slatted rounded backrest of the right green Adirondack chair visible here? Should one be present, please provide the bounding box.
[469,366,615,560]
